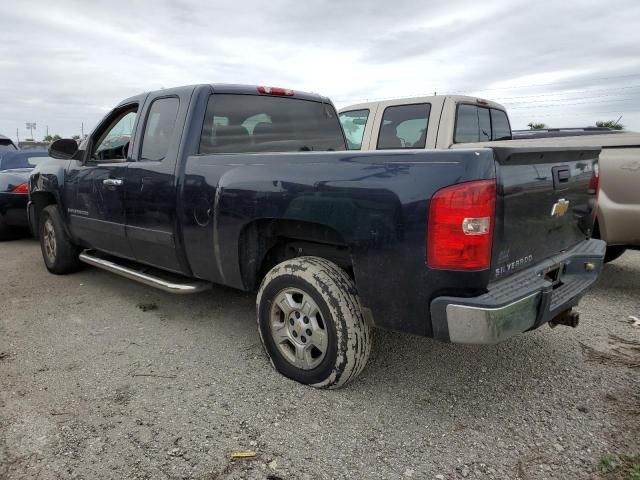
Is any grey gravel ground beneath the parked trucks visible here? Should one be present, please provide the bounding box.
[0,240,640,480]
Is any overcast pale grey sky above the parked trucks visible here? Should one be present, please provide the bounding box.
[0,0,640,139]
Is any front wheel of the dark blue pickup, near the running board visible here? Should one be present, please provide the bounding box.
[38,205,82,275]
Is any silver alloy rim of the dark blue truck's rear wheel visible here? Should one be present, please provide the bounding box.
[269,288,329,370]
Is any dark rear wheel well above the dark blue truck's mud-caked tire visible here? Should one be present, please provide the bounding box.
[238,220,353,290]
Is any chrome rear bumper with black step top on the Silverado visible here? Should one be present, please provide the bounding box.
[431,240,606,344]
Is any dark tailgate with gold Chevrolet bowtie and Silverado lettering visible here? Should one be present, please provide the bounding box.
[491,146,600,280]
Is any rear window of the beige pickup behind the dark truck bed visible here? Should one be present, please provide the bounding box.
[453,103,511,143]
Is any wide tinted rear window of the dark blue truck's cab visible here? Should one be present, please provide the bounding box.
[199,93,346,154]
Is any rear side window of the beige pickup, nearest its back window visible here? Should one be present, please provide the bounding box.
[377,103,431,150]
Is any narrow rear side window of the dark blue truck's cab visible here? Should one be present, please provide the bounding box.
[140,97,180,161]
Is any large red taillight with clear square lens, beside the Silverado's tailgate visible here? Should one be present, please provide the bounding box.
[427,180,496,270]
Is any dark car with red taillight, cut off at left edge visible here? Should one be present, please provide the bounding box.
[0,150,48,240]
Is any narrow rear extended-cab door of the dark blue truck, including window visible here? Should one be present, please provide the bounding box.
[120,88,192,274]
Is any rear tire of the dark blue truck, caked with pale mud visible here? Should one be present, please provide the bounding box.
[256,257,373,388]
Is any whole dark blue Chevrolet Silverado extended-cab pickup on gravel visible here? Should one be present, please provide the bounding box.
[28,85,605,387]
